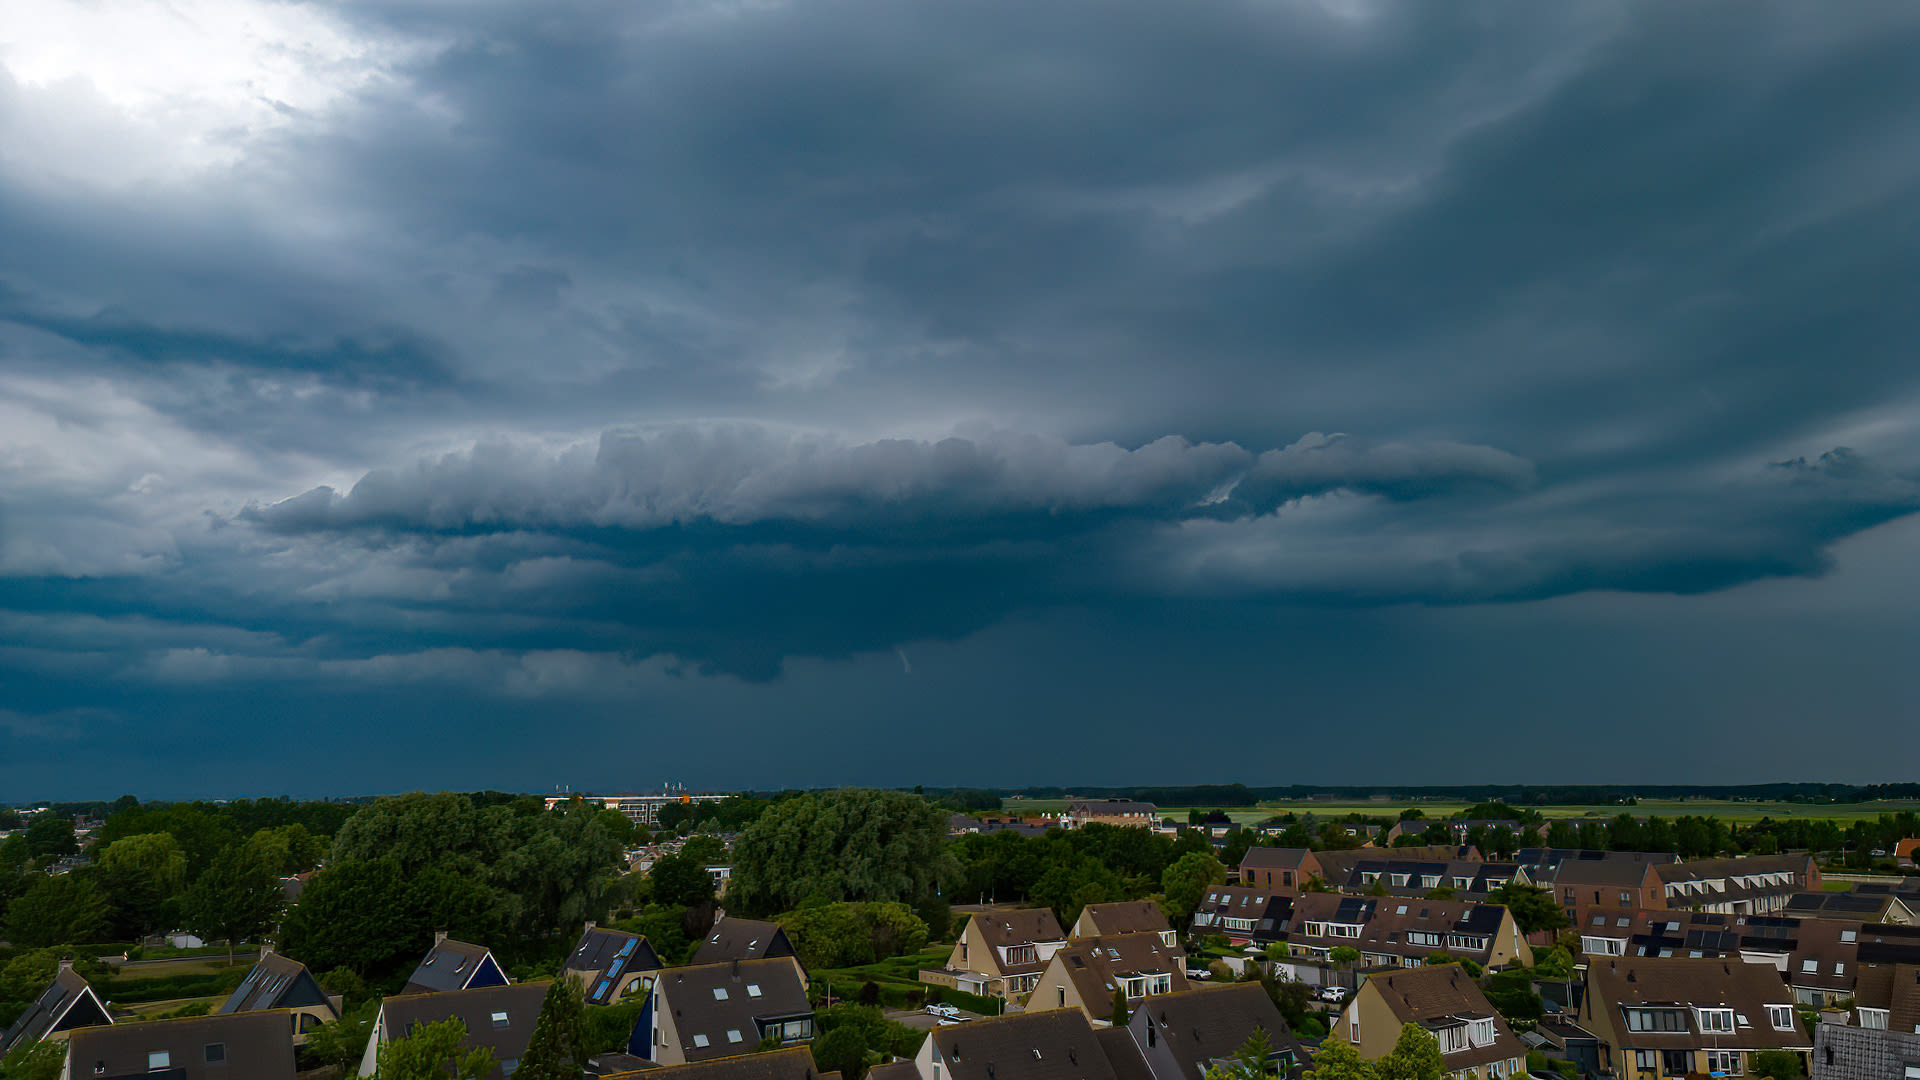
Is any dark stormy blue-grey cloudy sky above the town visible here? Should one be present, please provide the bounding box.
[0,0,1920,799]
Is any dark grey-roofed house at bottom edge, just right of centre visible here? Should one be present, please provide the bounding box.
[1127,982,1308,1080]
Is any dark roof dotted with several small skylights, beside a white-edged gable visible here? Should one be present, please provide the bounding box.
[653,957,812,1061]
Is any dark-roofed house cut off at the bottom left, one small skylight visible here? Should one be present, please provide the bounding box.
[60,1011,294,1080]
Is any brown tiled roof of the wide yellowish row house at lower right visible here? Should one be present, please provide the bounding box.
[1586,957,1812,1049]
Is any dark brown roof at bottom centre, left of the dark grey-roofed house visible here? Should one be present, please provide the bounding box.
[927,1009,1117,1080]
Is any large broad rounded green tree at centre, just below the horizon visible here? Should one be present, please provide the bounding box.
[728,788,956,913]
